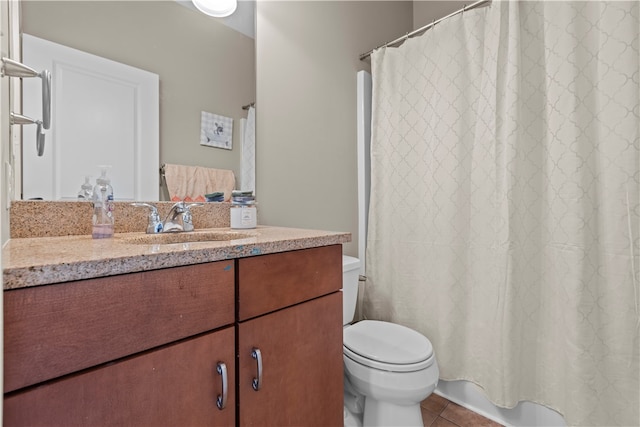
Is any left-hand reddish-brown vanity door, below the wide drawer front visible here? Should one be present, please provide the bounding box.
[4,327,235,426]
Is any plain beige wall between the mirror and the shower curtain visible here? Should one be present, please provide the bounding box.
[256,1,412,255]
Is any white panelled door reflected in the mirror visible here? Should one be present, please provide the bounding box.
[22,34,160,201]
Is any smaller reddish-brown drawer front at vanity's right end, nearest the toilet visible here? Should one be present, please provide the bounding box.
[237,245,342,321]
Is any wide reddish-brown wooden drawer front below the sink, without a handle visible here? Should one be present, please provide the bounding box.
[4,260,235,392]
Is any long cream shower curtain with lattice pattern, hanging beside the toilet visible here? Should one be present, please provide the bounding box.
[364,0,640,426]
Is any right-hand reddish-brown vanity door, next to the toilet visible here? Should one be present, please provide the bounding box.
[238,292,344,427]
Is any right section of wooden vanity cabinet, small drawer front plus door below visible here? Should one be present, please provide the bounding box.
[237,246,344,426]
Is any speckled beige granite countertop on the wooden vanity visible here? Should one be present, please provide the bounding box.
[2,226,351,290]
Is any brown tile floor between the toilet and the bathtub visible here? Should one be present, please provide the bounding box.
[420,393,501,427]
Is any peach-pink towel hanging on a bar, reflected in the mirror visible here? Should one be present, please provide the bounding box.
[164,164,236,202]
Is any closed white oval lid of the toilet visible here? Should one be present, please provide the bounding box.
[343,320,433,365]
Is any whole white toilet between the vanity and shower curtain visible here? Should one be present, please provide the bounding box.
[342,256,439,427]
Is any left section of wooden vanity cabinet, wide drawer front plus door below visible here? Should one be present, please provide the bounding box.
[3,260,235,426]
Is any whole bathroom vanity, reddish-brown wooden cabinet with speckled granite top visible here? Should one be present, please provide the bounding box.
[3,221,350,426]
